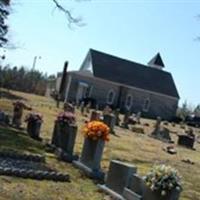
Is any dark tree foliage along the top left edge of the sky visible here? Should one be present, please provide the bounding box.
[0,0,10,47]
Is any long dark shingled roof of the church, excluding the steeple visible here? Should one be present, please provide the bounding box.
[89,49,179,98]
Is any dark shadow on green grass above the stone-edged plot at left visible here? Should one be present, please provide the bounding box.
[0,126,45,154]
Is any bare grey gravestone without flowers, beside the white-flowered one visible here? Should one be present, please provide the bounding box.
[99,160,137,199]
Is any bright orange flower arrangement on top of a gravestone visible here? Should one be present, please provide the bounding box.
[83,121,110,141]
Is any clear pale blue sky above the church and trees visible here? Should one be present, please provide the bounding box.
[0,0,200,105]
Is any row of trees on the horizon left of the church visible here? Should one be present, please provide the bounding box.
[0,66,52,95]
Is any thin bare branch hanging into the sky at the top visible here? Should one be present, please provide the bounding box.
[52,0,84,28]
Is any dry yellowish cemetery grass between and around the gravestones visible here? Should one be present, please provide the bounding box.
[0,91,200,200]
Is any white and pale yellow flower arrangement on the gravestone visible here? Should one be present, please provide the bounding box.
[145,165,182,196]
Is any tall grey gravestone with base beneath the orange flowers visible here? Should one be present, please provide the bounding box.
[73,138,105,180]
